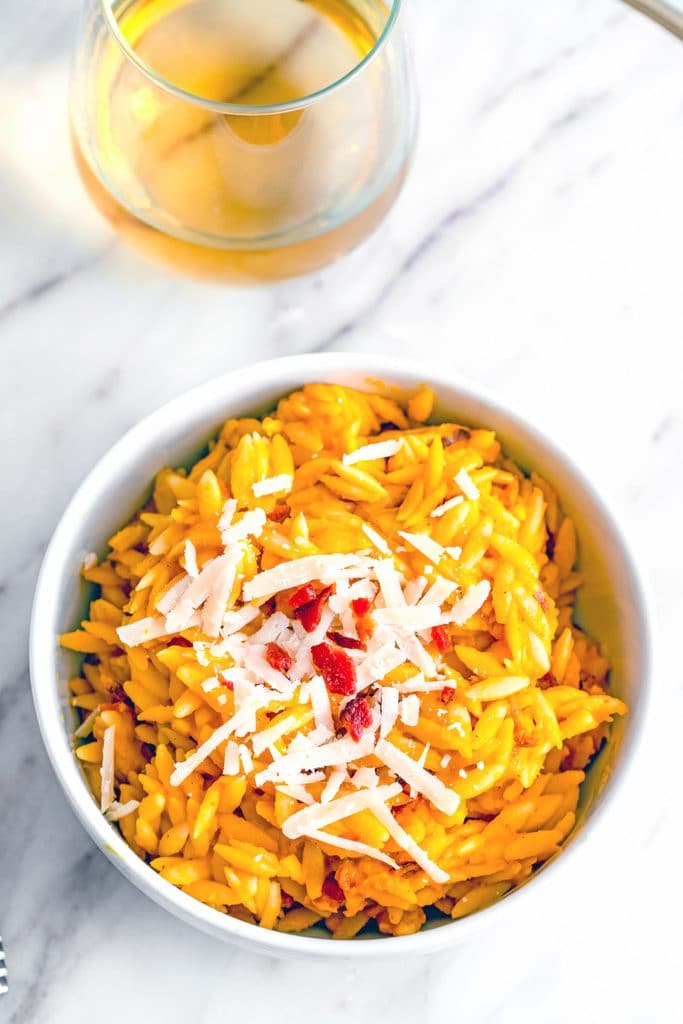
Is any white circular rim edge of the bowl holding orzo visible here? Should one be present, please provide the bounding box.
[29,352,654,958]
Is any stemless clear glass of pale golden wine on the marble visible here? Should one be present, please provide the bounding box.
[71,0,417,281]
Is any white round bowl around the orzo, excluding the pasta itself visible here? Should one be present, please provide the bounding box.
[31,354,651,957]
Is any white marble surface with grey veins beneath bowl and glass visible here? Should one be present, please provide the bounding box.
[0,0,683,1024]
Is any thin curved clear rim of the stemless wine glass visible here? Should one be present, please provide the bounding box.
[99,0,402,116]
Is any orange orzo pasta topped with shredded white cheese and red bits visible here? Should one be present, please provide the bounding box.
[61,384,627,938]
